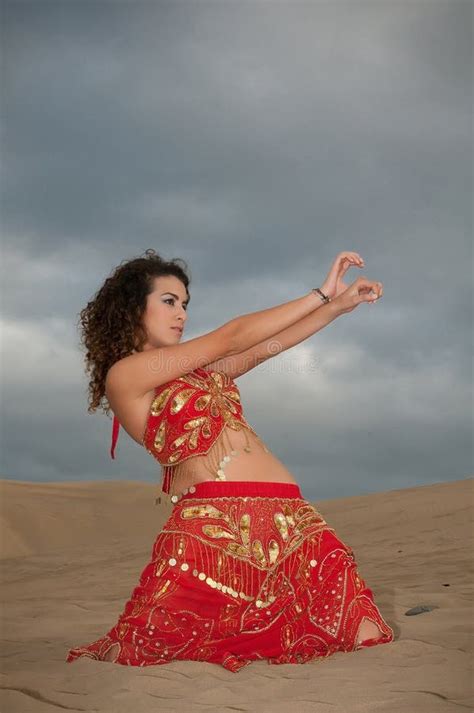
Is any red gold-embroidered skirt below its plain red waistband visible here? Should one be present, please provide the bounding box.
[67,496,393,672]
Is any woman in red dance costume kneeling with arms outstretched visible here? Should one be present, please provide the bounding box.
[66,250,394,672]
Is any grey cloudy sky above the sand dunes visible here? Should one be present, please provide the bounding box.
[1,0,473,500]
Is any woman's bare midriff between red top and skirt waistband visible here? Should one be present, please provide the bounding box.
[165,426,297,495]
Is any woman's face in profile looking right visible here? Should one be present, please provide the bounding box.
[143,275,188,350]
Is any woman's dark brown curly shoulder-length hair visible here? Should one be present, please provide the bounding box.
[79,248,191,415]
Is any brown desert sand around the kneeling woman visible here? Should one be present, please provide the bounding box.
[0,478,474,713]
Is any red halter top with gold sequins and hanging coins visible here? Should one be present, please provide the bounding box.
[110,367,268,493]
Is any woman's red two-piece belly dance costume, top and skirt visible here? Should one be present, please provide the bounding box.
[66,367,394,672]
